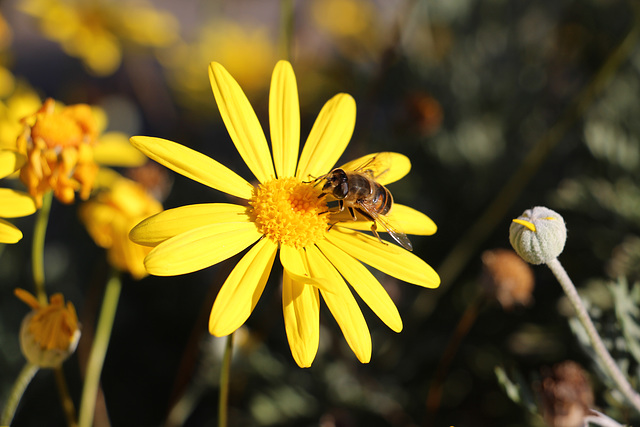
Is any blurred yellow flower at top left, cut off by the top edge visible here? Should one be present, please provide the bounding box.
[18,0,179,76]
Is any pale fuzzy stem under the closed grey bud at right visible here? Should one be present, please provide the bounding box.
[547,258,640,413]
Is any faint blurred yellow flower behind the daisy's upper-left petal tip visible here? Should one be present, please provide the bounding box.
[161,19,277,112]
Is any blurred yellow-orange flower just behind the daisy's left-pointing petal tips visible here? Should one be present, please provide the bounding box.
[80,175,162,279]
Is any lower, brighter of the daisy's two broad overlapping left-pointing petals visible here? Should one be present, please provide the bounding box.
[144,222,262,276]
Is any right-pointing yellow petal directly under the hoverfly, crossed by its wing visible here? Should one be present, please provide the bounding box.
[338,203,438,236]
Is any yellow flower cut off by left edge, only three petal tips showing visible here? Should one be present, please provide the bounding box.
[0,150,36,243]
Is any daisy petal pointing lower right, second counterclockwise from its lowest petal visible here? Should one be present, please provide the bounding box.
[317,241,402,332]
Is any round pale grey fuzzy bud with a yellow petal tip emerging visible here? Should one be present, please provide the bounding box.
[509,206,567,264]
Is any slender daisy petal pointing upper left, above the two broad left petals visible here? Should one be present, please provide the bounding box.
[130,136,253,199]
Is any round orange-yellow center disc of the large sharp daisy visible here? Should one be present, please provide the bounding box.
[249,178,329,248]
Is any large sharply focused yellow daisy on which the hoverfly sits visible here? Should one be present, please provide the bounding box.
[130,61,440,367]
